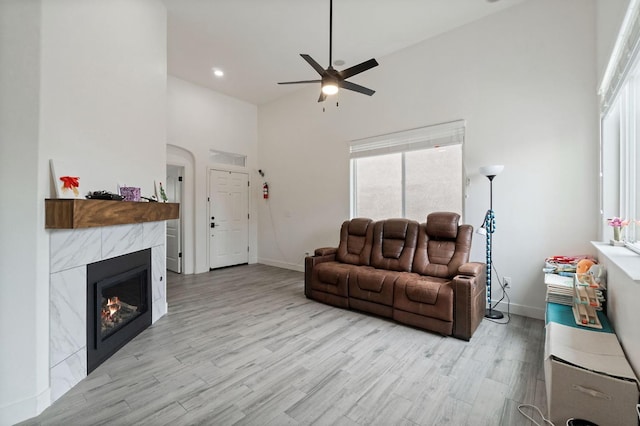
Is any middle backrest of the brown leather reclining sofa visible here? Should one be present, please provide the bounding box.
[371,219,420,272]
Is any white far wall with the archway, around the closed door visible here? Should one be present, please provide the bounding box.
[167,76,261,273]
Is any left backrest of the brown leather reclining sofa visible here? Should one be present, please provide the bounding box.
[336,218,373,265]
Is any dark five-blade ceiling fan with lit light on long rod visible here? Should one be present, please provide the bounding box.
[278,0,378,102]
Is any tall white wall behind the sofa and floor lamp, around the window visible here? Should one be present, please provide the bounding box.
[259,0,598,318]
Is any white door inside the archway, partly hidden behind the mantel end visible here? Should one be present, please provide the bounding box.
[165,165,184,274]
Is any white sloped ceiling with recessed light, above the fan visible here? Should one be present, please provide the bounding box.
[163,0,525,104]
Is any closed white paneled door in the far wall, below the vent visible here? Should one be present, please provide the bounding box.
[209,170,249,269]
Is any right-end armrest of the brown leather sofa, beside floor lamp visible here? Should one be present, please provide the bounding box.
[452,262,487,340]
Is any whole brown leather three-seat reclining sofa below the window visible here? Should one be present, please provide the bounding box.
[305,212,486,340]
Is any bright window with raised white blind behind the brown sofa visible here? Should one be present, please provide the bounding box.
[351,121,464,222]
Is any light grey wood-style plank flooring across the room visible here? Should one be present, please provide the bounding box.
[23,265,546,426]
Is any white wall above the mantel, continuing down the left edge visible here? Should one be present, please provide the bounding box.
[0,0,166,425]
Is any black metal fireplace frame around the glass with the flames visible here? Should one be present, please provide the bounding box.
[87,249,152,374]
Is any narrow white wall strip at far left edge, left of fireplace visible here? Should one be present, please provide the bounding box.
[0,0,49,425]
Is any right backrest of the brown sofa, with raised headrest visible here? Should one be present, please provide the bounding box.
[412,212,473,278]
